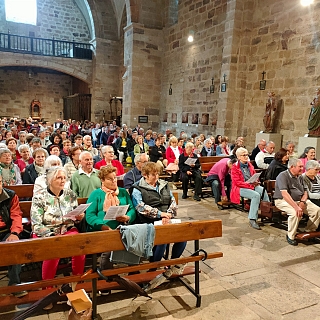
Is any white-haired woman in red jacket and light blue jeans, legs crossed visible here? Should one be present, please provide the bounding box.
[230,147,269,230]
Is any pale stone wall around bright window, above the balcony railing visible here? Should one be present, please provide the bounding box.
[0,0,90,42]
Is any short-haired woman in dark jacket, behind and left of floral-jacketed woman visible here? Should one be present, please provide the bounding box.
[23,148,47,184]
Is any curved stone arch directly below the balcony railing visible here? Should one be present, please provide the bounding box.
[0,54,92,85]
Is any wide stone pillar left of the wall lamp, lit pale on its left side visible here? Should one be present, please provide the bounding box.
[122,23,163,130]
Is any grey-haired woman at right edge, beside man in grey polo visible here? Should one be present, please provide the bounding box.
[302,160,320,207]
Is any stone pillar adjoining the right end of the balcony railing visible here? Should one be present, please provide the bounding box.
[90,38,120,122]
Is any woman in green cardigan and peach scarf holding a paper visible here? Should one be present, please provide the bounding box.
[86,165,136,270]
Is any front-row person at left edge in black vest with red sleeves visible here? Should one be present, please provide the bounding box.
[0,175,28,298]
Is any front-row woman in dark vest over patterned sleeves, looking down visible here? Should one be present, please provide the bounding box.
[132,162,186,261]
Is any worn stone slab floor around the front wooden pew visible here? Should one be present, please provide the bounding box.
[0,189,320,320]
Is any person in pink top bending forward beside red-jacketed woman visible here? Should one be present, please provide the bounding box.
[206,157,237,203]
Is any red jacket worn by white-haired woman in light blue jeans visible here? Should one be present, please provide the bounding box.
[230,161,256,204]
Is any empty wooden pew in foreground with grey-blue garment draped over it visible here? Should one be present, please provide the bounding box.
[0,220,223,319]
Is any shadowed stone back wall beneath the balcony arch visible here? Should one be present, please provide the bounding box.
[0,69,72,121]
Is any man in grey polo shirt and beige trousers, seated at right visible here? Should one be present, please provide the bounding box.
[273,158,320,246]
